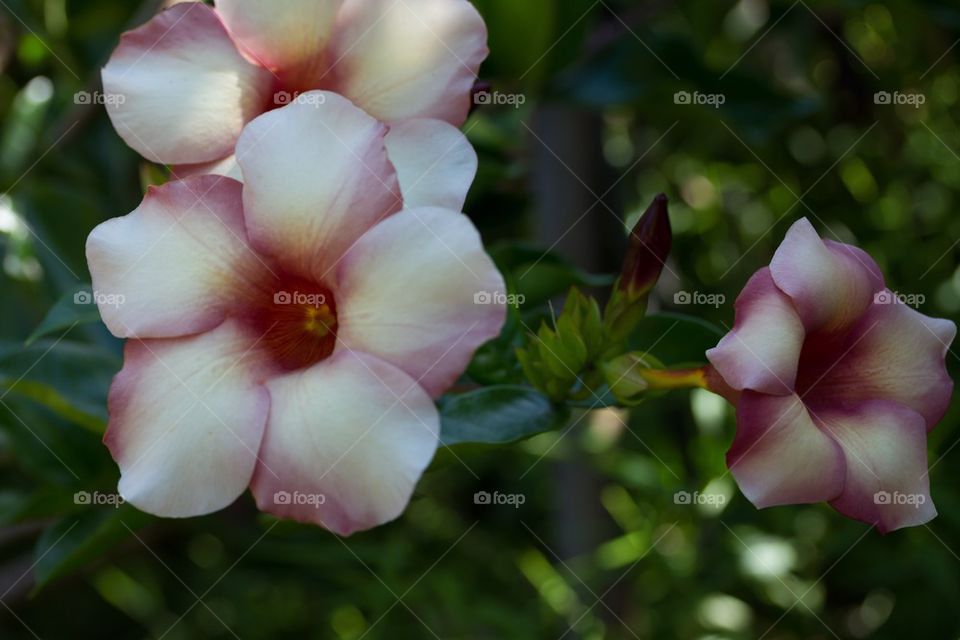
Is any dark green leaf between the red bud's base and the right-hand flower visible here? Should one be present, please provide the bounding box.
[627,313,724,366]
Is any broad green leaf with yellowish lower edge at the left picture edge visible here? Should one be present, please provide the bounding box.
[0,340,121,433]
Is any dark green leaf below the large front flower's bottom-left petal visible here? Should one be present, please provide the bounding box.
[33,504,152,593]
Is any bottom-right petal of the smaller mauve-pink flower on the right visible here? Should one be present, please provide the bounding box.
[815,400,937,533]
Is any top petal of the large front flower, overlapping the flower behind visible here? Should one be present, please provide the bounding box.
[237,91,401,281]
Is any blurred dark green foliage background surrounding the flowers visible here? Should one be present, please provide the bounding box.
[0,0,960,640]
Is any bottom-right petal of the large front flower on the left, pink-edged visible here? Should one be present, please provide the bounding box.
[251,350,440,535]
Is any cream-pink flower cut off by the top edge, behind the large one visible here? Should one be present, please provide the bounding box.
[102,0,488,192]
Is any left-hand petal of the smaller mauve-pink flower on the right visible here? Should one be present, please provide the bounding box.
[707,268,805,395]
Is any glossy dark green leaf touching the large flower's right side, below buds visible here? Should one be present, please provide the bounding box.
[440,385,563,446]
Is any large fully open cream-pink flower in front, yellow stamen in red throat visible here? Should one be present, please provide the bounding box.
[87,94,506,534]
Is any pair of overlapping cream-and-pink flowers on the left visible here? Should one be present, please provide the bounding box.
[87,0,506,534]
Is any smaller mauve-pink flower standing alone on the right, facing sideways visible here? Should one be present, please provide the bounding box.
[707,219,956,532]
